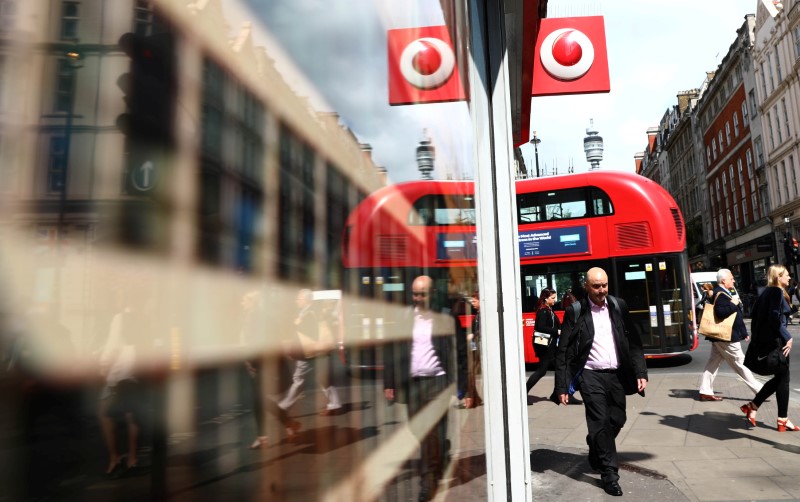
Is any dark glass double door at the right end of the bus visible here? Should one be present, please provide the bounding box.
[611,256,692,354]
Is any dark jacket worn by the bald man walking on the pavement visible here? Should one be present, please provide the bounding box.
[555,296,647,394]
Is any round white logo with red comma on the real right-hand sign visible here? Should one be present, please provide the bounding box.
[540,28,594,80]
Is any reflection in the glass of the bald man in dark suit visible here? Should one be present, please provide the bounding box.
[383,275,456,501]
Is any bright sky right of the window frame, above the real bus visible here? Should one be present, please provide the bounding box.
[522,0,759,174]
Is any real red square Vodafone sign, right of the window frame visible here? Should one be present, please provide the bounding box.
[531,16,611,96]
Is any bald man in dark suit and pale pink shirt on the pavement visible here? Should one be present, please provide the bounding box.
[555,268,647,496]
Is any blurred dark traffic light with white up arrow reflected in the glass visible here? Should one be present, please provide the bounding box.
[117,32,177,195]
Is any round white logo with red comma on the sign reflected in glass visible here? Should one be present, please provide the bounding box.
[400,37,456,90]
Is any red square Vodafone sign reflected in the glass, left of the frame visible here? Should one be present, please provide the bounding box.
[387,26,466,105]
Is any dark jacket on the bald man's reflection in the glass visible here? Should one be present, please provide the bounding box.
[383,307,463,403]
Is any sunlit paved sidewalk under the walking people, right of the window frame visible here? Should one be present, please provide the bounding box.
[484,373,800,502]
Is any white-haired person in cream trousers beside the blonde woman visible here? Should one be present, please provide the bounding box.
[699,268,762,401]
